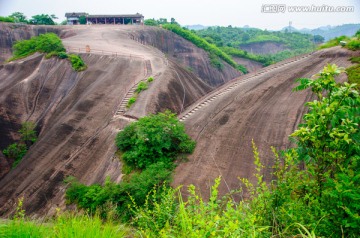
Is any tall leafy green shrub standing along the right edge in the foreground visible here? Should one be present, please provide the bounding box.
[291,65,360,237]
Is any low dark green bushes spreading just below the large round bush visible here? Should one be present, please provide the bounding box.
[66,162,172,219]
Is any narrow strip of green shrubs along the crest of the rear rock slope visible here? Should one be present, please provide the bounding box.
[163,24,248,73]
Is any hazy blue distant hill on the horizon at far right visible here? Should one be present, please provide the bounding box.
[282,24,360,41]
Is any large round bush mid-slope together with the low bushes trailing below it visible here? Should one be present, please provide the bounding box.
[66,112,195,219]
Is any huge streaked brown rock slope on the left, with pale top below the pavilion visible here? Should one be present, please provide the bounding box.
[0,26,212,216]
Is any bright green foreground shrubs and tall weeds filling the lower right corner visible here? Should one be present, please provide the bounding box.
[132,65,360,237]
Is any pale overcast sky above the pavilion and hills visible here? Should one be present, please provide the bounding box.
[0,0,360,30]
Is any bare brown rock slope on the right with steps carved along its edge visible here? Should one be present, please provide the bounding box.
[174,48,358,198]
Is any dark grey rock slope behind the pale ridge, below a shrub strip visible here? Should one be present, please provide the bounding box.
[131,27,241,86]
